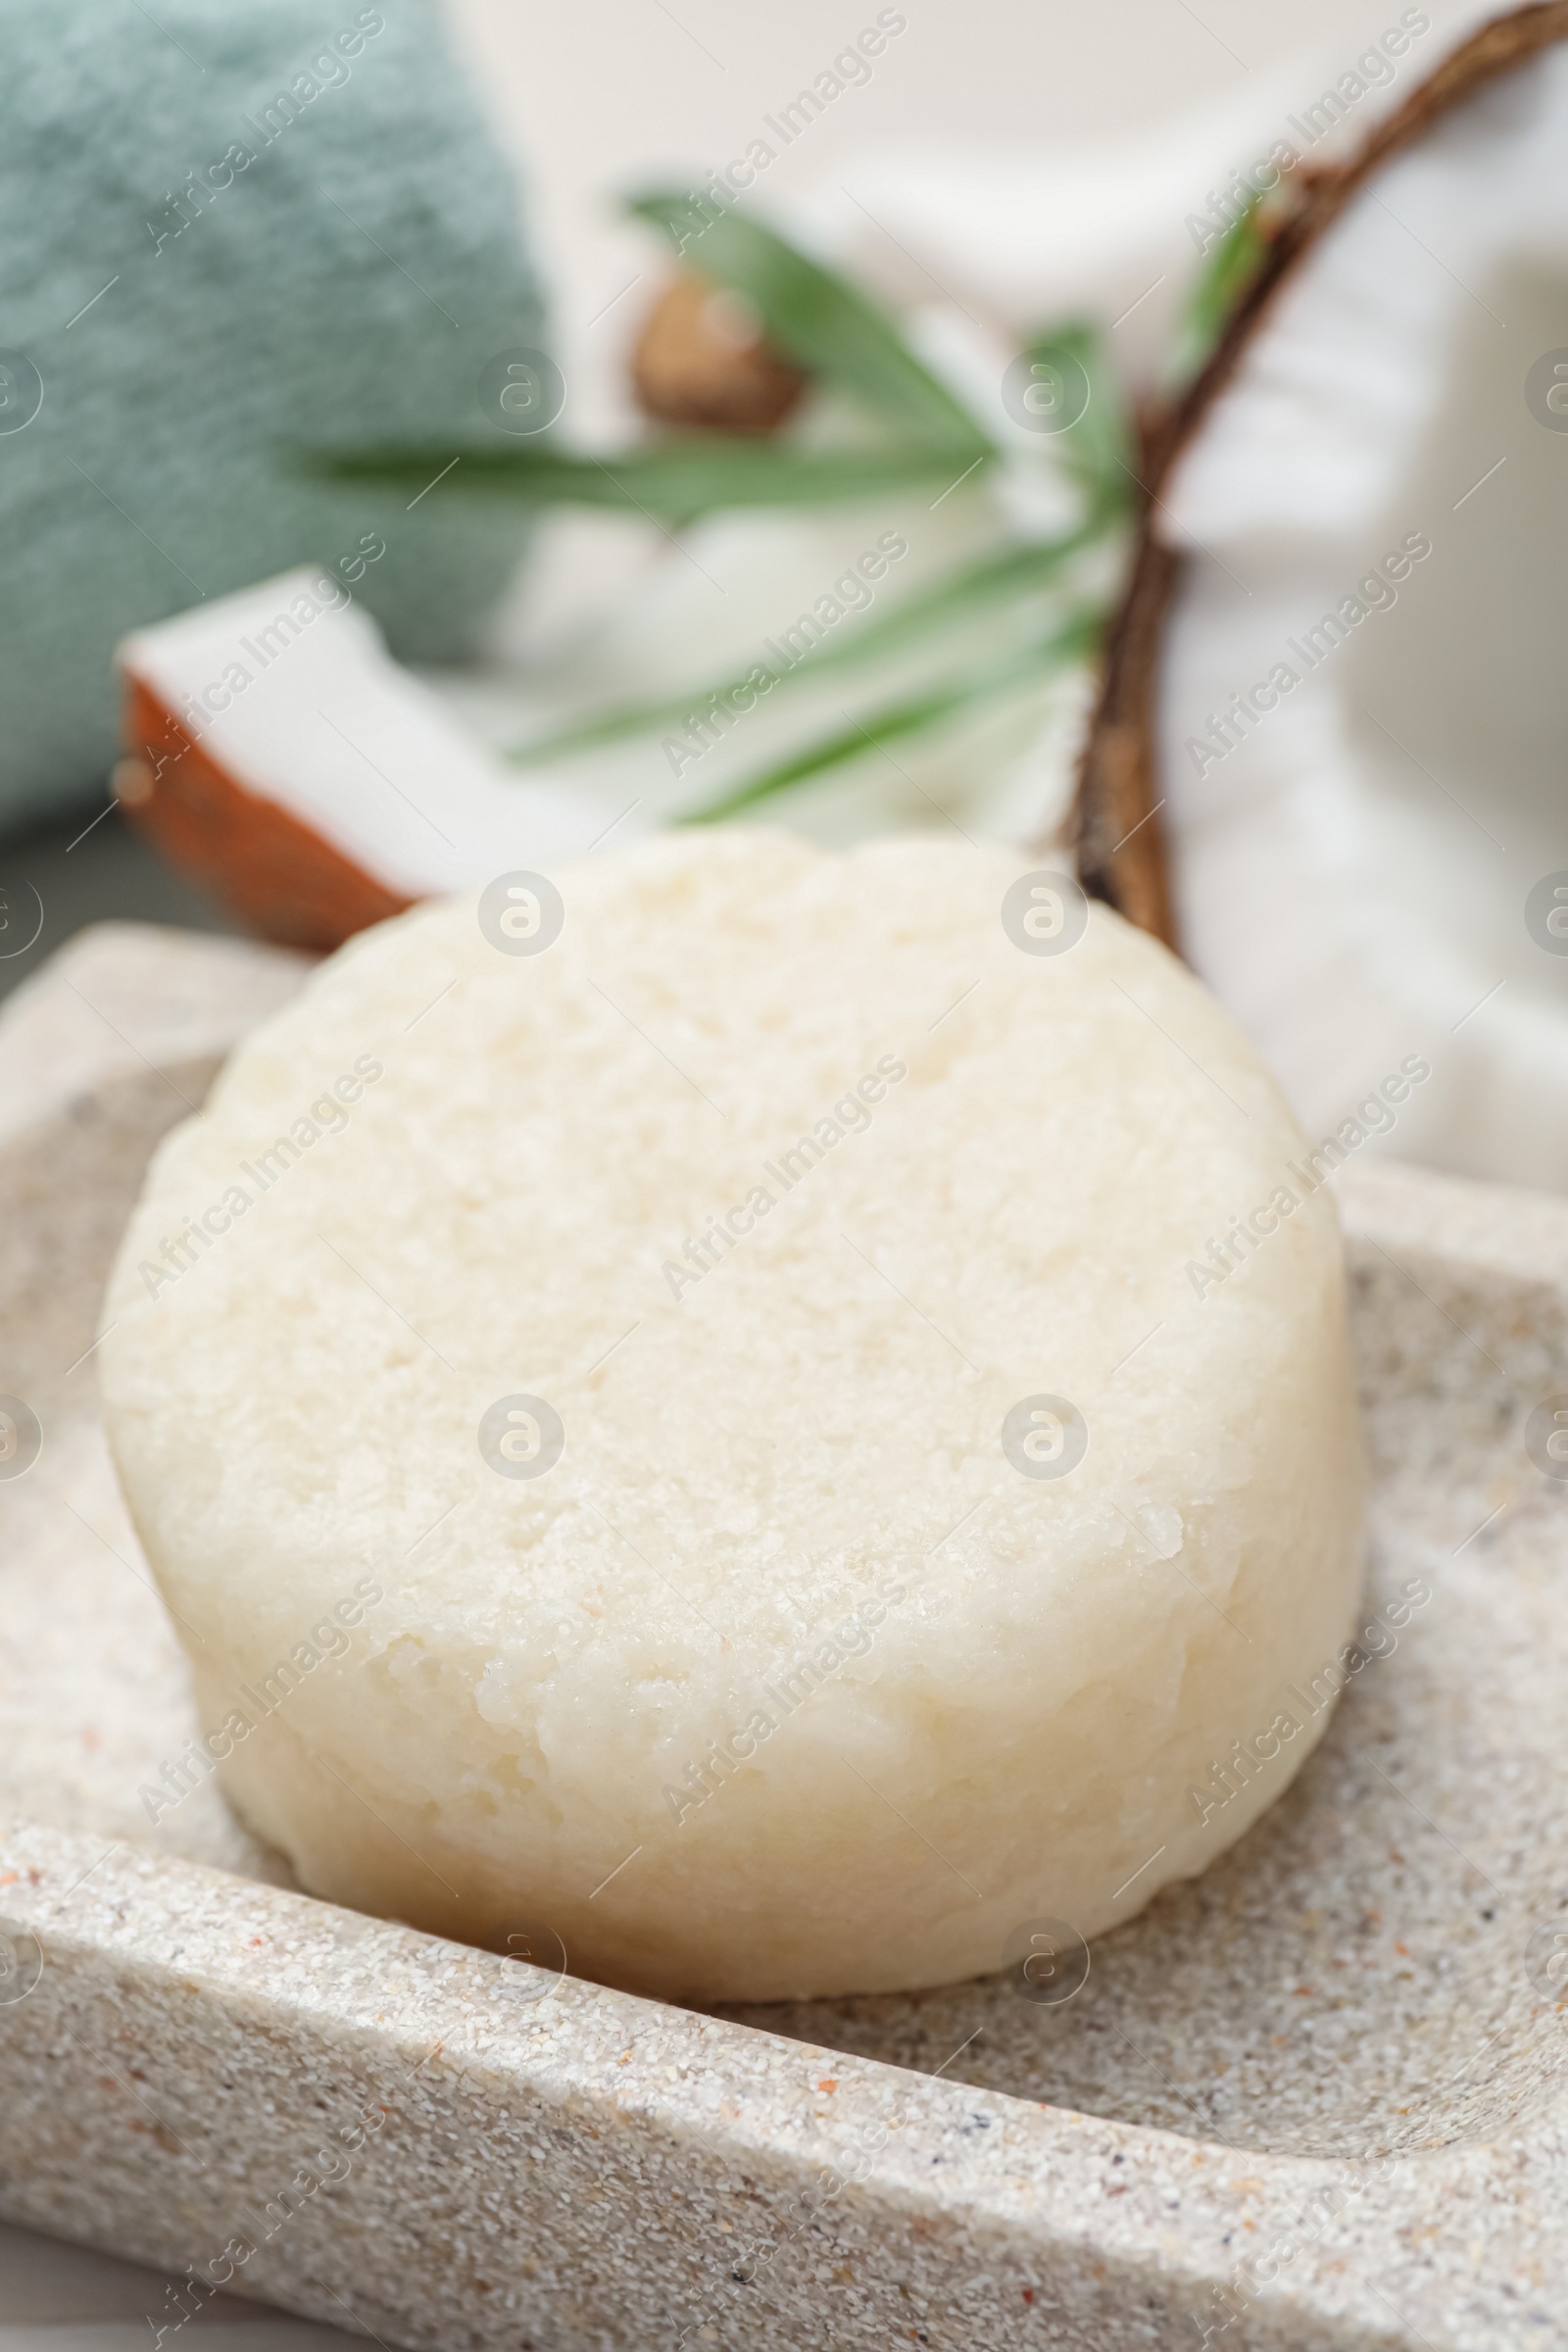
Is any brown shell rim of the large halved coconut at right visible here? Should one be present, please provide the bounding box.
[1062,0,1568,948]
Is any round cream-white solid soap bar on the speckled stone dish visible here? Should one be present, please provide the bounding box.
[101,830,1361,1999]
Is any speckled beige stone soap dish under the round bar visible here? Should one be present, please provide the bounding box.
[0,927,1568,2352]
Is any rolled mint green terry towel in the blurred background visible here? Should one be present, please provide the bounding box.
[0,0,541,828]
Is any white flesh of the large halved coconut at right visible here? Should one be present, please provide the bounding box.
[1159,49,1568,1188]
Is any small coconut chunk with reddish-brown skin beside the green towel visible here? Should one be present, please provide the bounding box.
[116,566,602,948]
